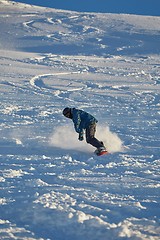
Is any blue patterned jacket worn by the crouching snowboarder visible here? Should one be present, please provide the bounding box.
[71,108,98,133]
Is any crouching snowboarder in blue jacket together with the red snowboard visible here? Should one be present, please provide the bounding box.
[63,107,106,155]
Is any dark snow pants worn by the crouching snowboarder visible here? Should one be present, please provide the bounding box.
[86,123,104,148]
